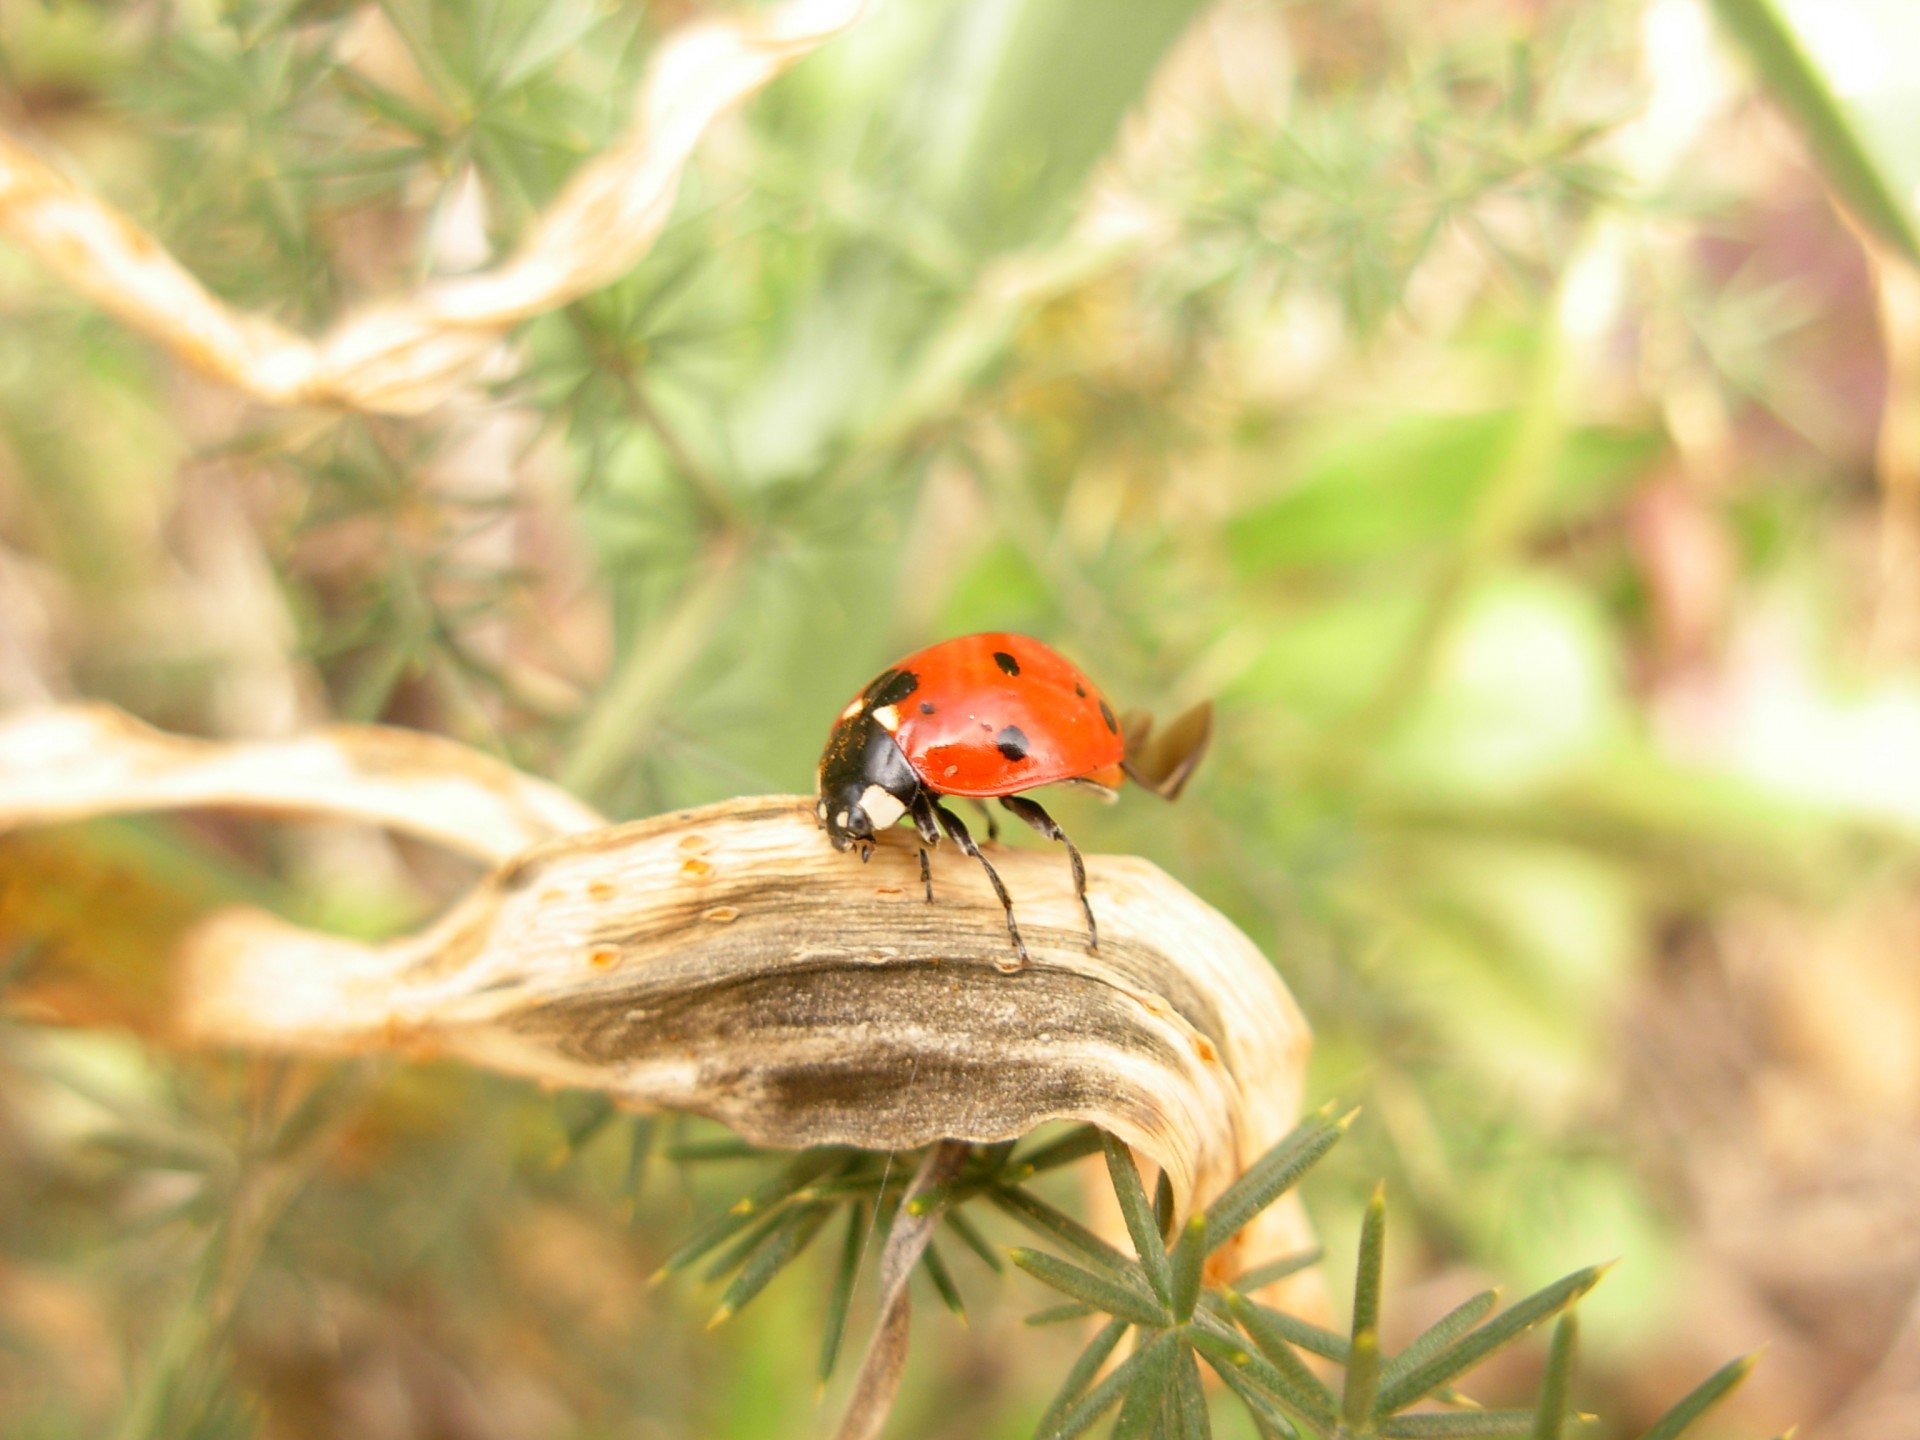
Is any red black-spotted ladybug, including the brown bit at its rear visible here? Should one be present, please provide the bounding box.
[816,632,1213,964]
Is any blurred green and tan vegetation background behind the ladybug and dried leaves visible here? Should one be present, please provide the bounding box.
[0,0,1920,1440]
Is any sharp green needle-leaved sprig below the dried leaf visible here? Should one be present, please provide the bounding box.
[652,1110,1753,1440]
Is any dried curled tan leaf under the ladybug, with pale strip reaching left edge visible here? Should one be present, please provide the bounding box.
[0,708,1311,1297]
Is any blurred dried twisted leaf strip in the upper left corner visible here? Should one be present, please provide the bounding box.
[0,0,864,415]
